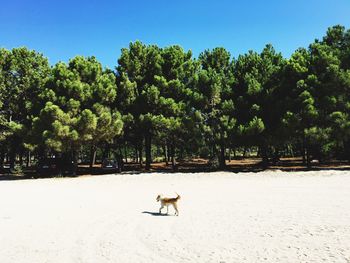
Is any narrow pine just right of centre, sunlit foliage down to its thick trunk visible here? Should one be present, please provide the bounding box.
[198,48,236,168]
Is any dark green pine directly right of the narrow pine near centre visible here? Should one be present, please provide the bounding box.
[235,45,284,164]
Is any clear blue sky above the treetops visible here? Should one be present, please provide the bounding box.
[0,0,350,68]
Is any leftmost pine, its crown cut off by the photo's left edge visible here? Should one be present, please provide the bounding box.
[0,47,50,168]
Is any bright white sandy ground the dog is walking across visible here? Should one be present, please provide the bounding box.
[0,171,350,263]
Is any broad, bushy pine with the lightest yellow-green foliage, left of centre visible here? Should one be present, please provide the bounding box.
[34,56,123,164]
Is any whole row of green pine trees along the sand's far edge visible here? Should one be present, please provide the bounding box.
[0,26,350,169]
